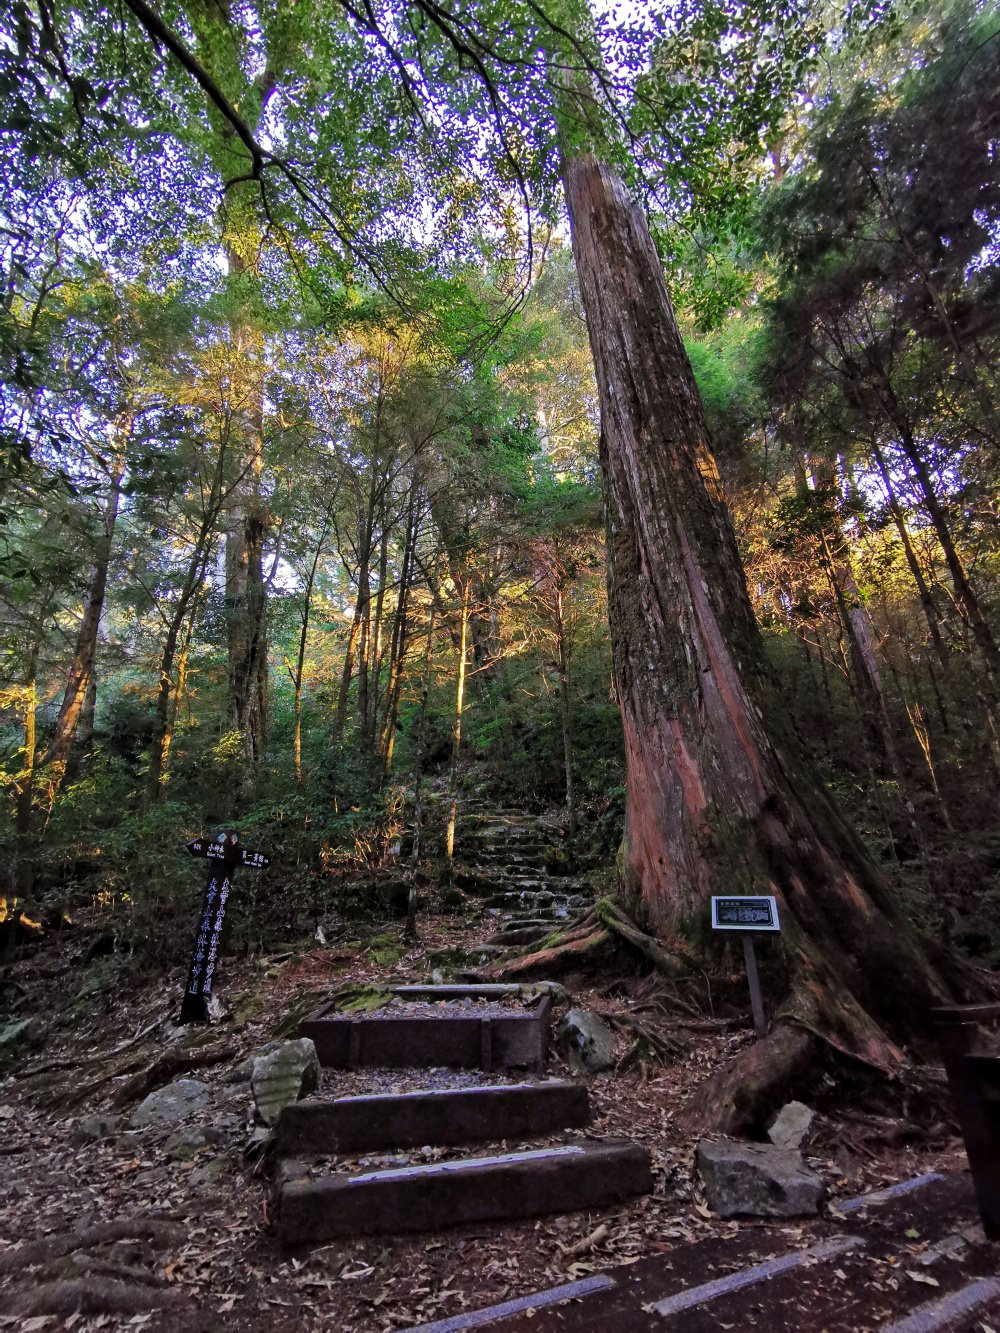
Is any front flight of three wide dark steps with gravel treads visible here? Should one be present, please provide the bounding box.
[276,986,652,1246]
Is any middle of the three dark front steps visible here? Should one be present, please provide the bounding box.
[276,1078,591,1157]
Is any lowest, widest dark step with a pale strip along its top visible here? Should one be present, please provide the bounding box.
[277,1140,652,1245]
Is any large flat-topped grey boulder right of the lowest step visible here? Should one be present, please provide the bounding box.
[697,1138,823,1217]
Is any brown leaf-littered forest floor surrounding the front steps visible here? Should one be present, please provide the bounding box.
[0,916,986,1330]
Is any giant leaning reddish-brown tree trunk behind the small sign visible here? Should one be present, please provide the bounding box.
[564,155,965,1098]
